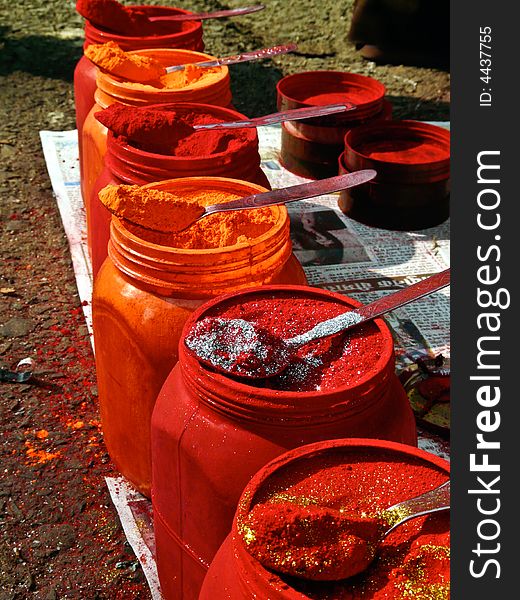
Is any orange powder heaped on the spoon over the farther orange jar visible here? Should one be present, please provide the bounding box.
[85,42,165,81]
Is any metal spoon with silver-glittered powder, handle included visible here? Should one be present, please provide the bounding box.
[185,268,450,379]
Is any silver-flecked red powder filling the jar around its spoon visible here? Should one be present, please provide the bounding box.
[186,292,383,392]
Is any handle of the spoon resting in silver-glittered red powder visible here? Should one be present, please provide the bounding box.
[285,270,450,345]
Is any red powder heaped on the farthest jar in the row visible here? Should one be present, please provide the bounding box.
[76,0,184,37]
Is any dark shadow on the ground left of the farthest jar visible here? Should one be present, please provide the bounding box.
[0,27,83,81]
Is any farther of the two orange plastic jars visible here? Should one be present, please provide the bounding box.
[79,48,232,211]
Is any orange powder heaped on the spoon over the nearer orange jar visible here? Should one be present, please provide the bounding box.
[99,185,204,232]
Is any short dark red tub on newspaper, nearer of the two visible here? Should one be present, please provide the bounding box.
[339,121,450,231]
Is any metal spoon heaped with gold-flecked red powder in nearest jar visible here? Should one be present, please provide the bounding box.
[244,480,450,581]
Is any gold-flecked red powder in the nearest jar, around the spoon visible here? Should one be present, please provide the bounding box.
[238,449,450,600]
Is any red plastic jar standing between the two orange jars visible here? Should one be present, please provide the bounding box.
[86,102,271,277]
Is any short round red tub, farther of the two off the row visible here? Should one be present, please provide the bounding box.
[276,71,392,179]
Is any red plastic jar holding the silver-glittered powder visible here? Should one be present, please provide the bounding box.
[152,286,417,600]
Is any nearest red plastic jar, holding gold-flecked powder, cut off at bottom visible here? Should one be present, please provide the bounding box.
[199,439,450,600]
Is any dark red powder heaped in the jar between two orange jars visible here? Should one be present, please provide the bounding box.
[94,103,258,157]
